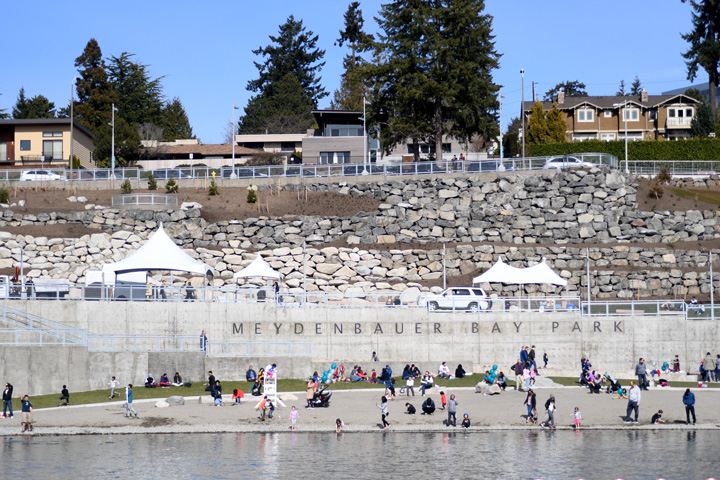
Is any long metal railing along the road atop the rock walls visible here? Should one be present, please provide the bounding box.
[0,153,617,182]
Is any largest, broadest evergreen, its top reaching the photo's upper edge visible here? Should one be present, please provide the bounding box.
[364,0,500,159]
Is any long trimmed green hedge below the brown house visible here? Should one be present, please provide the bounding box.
[527,138,720,160]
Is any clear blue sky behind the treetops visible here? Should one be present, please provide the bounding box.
[0,0,707,143]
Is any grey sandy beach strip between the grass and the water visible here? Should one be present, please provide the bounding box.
[0,386,720,436]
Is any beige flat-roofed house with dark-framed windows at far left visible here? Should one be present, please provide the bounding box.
[0,118,95,168]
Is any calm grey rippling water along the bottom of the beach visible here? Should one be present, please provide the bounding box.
[0,430,720,480]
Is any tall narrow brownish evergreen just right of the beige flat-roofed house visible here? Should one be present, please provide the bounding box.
[75,38,118,132]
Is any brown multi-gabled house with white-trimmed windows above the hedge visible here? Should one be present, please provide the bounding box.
[523,90,700,142]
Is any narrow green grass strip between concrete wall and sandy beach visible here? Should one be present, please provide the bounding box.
[8,374,490,412]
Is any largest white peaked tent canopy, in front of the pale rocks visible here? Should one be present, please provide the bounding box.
[102,224,212,277]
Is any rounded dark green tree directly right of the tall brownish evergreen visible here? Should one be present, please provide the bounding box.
[107,52,163,125]
